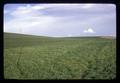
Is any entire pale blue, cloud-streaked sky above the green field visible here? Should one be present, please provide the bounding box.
[4,4,116,37]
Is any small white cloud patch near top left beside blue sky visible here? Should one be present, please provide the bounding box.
[10,5,45,17]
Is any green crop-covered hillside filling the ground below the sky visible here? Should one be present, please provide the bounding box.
[4,33,116,79]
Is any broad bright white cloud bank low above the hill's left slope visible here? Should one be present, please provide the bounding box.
[4,16,55,34]
